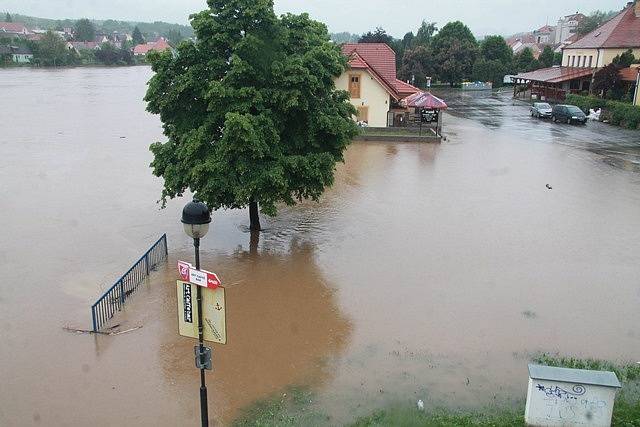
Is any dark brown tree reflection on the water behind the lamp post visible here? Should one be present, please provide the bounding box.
[156,240,350,422]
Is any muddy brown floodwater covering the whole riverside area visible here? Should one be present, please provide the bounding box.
[0,67,640,426]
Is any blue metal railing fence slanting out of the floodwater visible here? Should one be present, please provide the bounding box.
[91,234,168,332]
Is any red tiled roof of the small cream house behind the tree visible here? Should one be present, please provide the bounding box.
[342,43,419,99]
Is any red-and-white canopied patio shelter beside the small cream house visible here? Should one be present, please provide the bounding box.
[389,91,448,135]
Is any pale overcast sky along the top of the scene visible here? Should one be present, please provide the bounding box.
[0,0,627,37]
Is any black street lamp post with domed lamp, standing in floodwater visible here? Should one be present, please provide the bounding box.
[182,199,211,427]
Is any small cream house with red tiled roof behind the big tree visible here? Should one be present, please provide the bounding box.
[336,43,420,127]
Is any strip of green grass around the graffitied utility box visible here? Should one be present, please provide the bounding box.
[234,354,640,427]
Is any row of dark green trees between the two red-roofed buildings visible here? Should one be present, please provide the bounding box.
[358,21,558,87]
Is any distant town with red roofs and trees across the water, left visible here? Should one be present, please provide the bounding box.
[0,13,188,66]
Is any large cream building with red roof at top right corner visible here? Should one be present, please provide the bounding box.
[562,2,640,68]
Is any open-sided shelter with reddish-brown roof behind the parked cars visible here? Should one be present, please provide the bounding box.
[513,67,598,101]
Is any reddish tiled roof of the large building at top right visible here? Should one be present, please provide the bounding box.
[568,6,640,49]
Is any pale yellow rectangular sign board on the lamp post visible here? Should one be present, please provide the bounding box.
[177,280,227,344]
